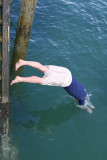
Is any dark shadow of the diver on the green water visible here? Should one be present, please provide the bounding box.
[22,102,79,133]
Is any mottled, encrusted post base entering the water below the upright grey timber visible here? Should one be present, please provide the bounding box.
[0,104,17,160]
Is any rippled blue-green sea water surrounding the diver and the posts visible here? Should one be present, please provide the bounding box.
[10,0,107,160]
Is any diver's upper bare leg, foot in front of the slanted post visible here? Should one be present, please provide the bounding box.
[15,59,47,72]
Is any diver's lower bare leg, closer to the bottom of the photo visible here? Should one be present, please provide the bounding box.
[10,76,44,85]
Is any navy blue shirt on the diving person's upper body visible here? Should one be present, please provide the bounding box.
[64,76,87,105]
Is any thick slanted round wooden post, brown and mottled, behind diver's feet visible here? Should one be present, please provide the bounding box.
[12,0,37,67]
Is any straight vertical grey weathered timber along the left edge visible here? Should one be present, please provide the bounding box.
[0,0,10,103]
